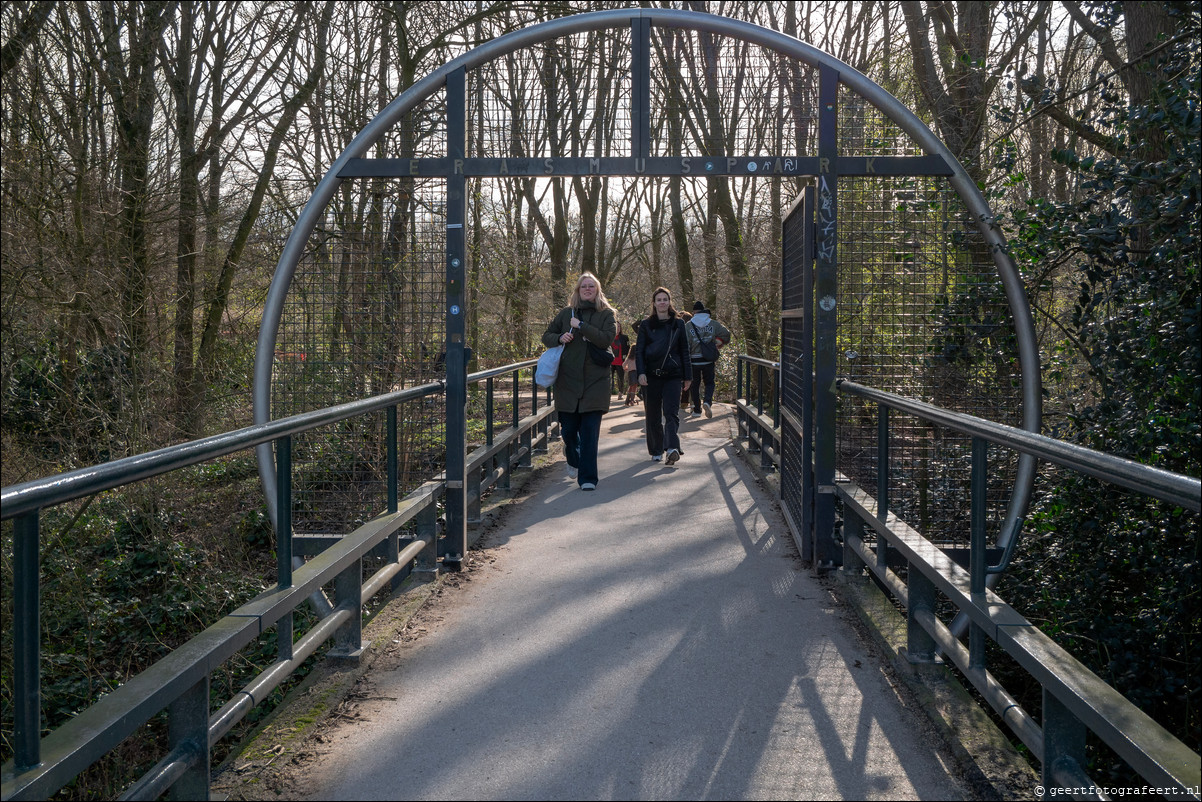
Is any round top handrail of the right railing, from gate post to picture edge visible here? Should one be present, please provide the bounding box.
[835,379,1202,512]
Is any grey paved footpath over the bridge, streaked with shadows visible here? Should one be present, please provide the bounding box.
[215,405,995,800]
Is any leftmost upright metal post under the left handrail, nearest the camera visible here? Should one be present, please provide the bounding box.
[12,510,42,768]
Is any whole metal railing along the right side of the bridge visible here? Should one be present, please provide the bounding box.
[737,357,1202,800]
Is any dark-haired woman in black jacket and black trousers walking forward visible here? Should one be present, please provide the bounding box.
[635,287,692,465]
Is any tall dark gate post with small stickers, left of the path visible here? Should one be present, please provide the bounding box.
[442,67,468,566]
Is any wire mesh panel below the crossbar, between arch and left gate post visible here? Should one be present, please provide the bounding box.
[272,179,446,533]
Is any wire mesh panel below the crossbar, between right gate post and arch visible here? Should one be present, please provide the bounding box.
[838,178,1020,543]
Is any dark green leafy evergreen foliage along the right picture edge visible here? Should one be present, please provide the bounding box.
[1010,2,1202,772]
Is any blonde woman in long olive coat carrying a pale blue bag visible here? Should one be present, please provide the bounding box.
[542,273,618,491]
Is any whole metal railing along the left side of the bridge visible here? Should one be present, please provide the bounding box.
[0,360,553,800]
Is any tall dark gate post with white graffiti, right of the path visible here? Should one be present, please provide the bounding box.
[814,65,839,571]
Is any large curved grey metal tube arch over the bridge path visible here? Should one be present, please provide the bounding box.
[251,8,1042,580]
